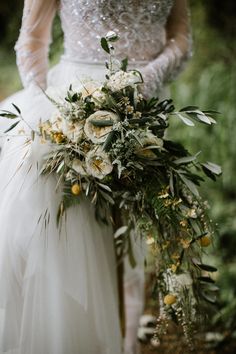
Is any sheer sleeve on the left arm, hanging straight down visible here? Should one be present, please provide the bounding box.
[15,0,57,88]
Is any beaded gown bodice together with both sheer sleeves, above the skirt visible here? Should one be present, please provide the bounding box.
[16,0,191,96]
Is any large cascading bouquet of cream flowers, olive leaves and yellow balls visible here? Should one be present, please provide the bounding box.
[1,33,221,344]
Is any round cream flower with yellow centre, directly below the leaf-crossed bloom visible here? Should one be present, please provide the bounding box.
[85,147,113,179]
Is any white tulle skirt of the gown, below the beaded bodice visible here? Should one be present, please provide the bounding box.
[0,60,148,354]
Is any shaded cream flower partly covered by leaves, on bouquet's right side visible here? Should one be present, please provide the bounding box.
[136,132,163,159]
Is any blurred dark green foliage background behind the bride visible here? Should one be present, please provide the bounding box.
[0,0,236,353]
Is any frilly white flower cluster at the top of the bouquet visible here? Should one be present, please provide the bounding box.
[107,70,142,92]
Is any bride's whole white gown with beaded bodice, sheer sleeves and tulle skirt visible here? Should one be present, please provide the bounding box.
[0,0,190,354]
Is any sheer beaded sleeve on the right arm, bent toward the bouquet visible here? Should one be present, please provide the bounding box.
[142,0,192,97]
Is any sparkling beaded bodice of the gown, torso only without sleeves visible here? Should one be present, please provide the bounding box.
[60,0,174,62]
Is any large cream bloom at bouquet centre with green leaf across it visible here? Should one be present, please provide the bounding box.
[84,111,119,144]
